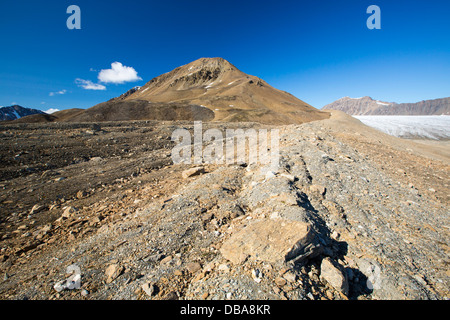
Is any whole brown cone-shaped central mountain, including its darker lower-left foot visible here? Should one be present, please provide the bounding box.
[69,58,329,124]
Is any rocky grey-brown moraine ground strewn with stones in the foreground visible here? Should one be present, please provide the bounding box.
[0,112,450,300]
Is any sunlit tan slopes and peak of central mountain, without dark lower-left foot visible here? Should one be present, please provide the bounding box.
[104,57,329,124]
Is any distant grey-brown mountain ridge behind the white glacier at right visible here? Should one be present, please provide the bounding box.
[322,97,450,116]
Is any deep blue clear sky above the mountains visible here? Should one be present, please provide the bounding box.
[0,0,450,110]
